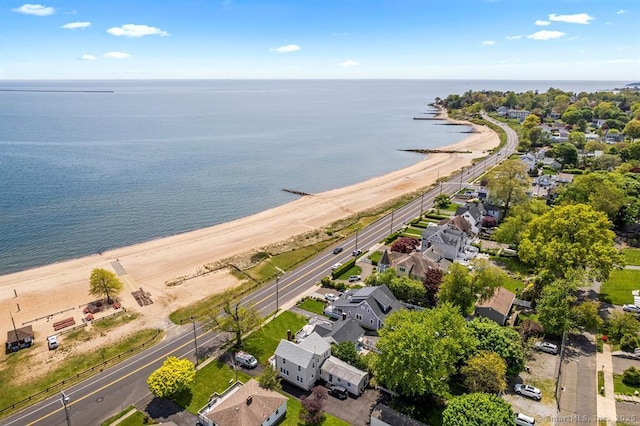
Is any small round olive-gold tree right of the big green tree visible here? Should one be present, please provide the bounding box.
[460,351,507,394]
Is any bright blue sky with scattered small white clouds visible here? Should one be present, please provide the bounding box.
[0,0,640,81]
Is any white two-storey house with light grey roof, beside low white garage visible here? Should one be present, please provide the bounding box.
[275,333,331,390]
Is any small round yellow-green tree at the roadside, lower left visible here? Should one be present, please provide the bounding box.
[147,356,196,398]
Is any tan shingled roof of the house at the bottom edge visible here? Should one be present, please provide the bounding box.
[205,379,287,426]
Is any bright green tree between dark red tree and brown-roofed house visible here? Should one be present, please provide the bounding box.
[438,259,507,315]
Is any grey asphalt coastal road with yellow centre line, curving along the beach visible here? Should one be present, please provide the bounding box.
[0,115,518,425]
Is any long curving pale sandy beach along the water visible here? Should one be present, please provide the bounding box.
[0,115,499,356]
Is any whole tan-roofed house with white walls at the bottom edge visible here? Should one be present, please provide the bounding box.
[198,379,288,426]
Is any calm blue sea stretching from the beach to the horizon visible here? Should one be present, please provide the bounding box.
[0,80,626,274]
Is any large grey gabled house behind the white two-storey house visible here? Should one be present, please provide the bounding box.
[331,285,404,330]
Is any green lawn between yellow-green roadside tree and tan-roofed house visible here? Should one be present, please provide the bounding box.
[173,360,251,414]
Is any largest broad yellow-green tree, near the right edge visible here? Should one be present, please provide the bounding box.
[518,204,622,281]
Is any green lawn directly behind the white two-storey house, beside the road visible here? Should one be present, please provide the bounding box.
[242,311,307,364]
